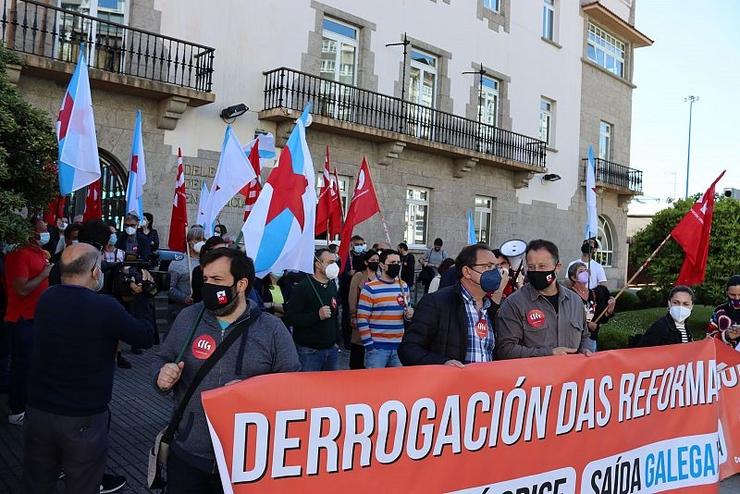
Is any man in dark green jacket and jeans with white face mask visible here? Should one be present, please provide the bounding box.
[283,249,340,371]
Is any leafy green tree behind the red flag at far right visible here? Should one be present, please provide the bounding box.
[630,196,740,305]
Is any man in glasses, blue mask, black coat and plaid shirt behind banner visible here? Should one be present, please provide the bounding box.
[398,245,501,367]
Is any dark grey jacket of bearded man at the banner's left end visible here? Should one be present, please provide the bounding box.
[152,301,301,472]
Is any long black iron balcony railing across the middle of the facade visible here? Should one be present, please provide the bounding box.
[264,67,546,169]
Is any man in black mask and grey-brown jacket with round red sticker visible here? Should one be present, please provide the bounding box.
[496,240,591,359]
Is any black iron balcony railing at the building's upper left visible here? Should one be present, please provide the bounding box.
[1,0,214,92]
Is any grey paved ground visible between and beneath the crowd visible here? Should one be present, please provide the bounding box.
[0,351,740,494]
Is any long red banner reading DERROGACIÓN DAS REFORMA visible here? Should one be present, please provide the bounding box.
[202,340,740,494]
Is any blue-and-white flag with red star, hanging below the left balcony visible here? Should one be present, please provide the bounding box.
[56,48,100,196]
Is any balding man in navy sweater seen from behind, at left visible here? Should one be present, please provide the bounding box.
[23,244,154,494]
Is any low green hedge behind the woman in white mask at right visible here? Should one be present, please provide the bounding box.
[598,304,714,350]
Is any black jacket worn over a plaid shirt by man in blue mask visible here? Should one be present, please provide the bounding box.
[398,283,498,365]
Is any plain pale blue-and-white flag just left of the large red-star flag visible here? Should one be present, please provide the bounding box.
[203,125,257,237]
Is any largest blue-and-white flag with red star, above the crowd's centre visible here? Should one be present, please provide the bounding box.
[242,103,316,277]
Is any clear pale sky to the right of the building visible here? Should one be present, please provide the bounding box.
[629,0,740,214]
